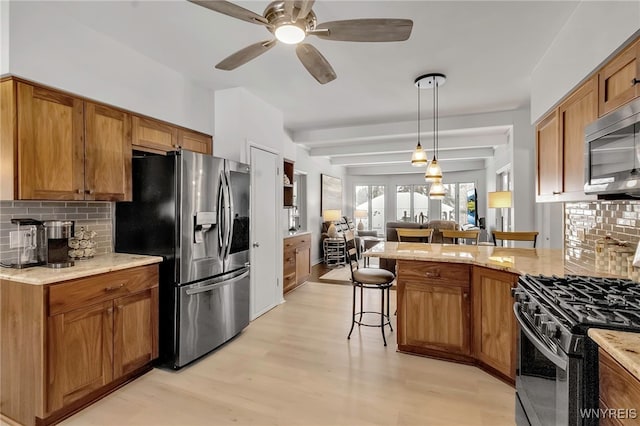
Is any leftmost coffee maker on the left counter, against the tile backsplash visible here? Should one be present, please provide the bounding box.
[3,218,47,269]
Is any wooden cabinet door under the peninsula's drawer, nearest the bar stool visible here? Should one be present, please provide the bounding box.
[398,281,470,355]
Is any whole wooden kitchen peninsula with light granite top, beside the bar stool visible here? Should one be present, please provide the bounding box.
[364,241,602,385]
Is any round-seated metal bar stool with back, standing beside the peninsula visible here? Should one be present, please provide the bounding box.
[343,231,396,346]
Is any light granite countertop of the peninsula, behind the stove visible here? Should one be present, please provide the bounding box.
[363,241,611,276]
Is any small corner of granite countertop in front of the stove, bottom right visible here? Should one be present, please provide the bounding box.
[588,328,640,380]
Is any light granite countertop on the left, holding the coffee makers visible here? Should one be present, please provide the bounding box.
[0,253,162,285]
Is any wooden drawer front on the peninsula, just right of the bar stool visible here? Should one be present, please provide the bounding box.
[398,260,471,287]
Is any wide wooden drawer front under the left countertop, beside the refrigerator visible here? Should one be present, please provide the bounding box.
[49,265,158,315]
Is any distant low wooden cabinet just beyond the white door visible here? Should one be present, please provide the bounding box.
[282,234,311,294]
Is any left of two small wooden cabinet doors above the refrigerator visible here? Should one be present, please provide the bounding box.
[131,115,178,153]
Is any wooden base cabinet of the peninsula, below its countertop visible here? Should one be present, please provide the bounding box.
[397,260,518,384]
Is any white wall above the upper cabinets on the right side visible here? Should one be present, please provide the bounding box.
[530,1,640,123]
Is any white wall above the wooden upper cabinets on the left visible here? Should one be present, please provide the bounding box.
[7,0,215,134]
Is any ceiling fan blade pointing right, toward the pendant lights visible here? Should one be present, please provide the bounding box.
[309,19,413,42]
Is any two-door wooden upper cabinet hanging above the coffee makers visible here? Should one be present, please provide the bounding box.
[0,79,131,201]
